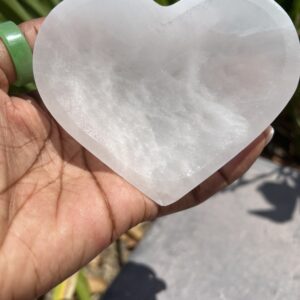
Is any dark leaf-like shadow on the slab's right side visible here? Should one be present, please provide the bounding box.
[228,167,300,223]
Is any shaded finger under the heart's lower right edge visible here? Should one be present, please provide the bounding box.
[160,127,274,216]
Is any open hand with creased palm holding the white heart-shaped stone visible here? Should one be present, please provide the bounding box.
[0,20,271,300]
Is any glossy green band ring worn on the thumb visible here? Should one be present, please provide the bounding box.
[0,21,33,87]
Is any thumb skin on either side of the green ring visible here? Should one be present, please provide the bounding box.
[0,18,44,92]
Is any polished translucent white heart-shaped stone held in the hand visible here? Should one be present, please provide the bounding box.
[34,0,300,205]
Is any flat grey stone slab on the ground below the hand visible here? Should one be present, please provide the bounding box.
[103,160,300,300]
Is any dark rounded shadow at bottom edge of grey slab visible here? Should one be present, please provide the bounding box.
[103,262,167,300]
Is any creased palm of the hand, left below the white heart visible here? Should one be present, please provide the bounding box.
[0,91,157,298]
